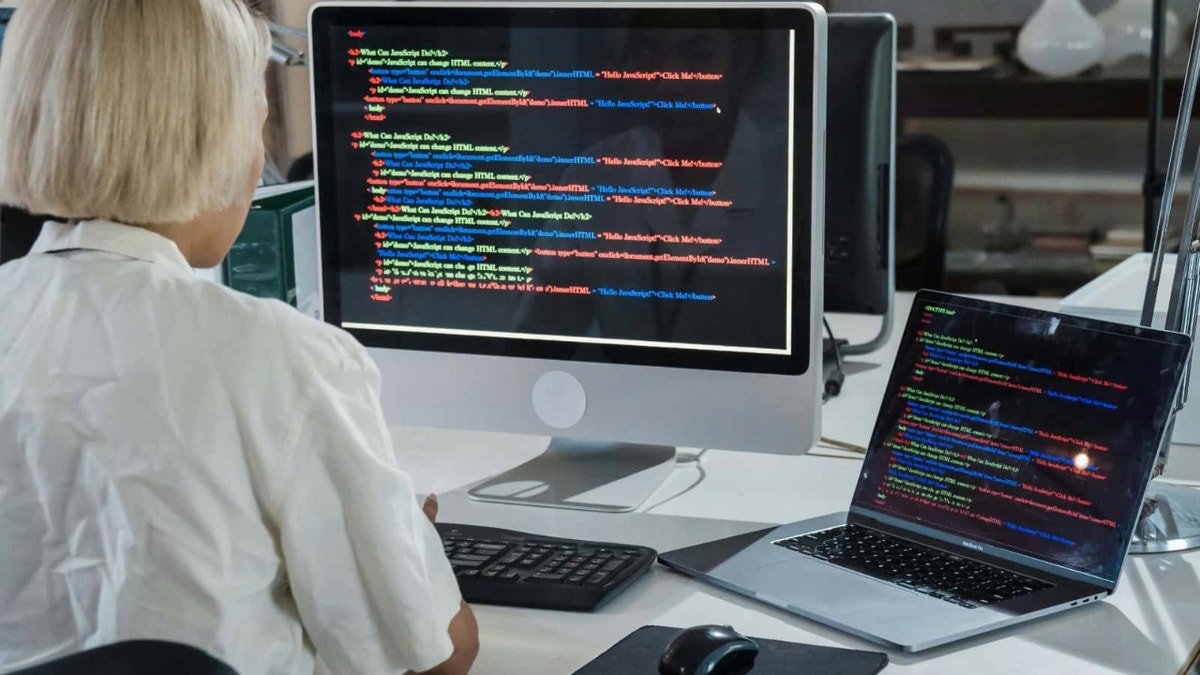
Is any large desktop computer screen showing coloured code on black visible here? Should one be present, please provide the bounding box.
[312,6,814,374]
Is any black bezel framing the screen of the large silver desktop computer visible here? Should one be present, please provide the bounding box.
[310,2,824,376]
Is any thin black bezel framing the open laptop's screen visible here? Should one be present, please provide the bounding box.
[850,289,1192,590]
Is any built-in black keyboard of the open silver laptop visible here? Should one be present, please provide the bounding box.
[775,525,1051,609]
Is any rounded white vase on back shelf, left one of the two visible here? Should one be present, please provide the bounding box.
[1016,0,1104,77]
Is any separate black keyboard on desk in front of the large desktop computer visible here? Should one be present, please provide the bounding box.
[437,522,658,611]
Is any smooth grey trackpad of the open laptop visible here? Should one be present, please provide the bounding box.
[730,557,920,615]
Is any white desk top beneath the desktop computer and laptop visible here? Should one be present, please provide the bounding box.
[392,294,1200,675]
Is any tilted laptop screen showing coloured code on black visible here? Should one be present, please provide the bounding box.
[853,292,1189,581]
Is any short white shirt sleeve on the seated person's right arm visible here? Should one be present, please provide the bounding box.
[280,345,461,675]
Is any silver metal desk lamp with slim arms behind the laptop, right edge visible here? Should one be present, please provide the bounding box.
[1129,3,1200,554]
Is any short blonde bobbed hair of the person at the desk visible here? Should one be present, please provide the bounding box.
[0,0,270,225]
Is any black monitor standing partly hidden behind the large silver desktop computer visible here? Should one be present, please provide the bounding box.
[824,13,896,353]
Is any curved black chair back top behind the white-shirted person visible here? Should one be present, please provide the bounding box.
[11,640,238,675]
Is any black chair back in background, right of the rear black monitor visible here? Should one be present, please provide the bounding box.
[895,133,954,291]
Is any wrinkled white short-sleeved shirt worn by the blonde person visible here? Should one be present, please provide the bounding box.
[0,221,461,675]
